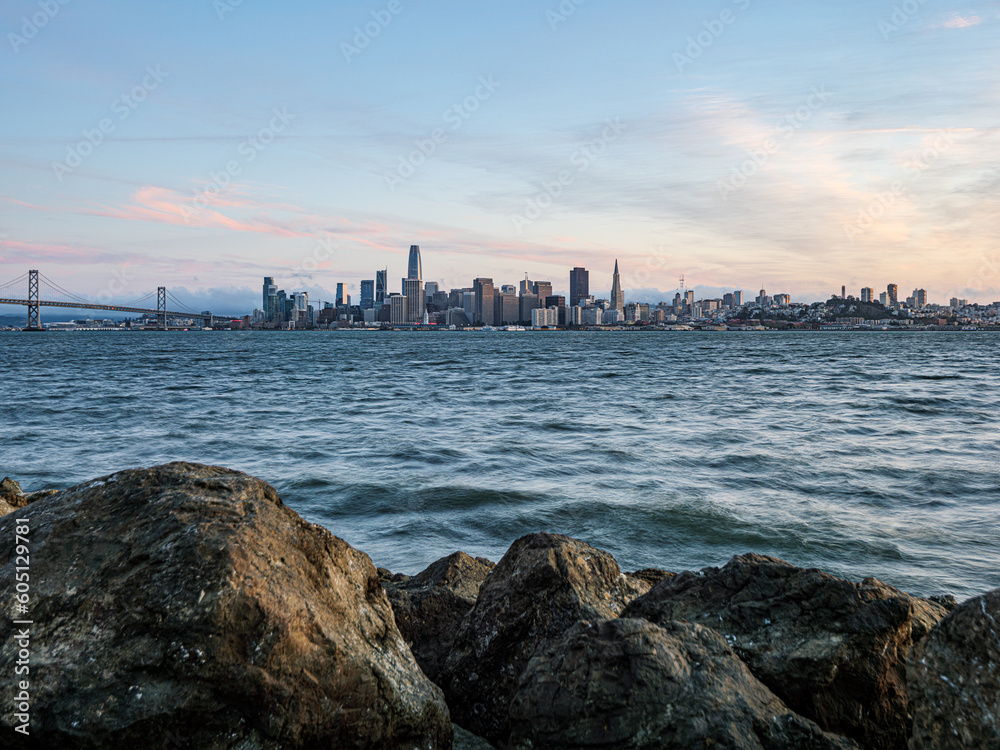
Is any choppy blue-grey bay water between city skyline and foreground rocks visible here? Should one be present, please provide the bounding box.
[0,332,1000,599]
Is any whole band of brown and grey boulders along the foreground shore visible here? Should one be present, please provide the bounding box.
[0,463,1000,750]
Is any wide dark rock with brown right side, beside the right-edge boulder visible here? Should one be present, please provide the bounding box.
[623,555,946,750]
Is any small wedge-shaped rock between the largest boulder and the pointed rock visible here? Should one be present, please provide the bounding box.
[382,552,494,682]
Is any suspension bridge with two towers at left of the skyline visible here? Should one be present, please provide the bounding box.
[0,270,212,331]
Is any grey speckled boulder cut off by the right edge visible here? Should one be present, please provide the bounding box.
[907,589,1000,750]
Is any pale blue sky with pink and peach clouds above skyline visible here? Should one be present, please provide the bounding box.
[0,0,1000,314]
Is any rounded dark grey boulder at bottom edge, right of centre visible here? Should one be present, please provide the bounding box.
[510,619,857,750]
